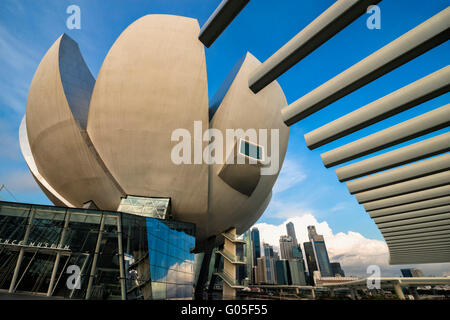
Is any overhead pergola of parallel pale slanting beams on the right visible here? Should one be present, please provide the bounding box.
[202,0,450,264]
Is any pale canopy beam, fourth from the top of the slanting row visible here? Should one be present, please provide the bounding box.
[305,66,450,150]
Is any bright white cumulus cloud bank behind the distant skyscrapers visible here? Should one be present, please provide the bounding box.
[255,212,450,278]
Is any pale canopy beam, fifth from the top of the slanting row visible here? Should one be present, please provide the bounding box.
[321,104,450,168]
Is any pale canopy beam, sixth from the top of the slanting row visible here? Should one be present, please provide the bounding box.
[336,132,450,182]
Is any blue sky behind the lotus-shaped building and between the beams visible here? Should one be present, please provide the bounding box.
[0,0,450,251]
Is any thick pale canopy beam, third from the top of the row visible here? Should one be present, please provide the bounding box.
[282,7,450,126]
